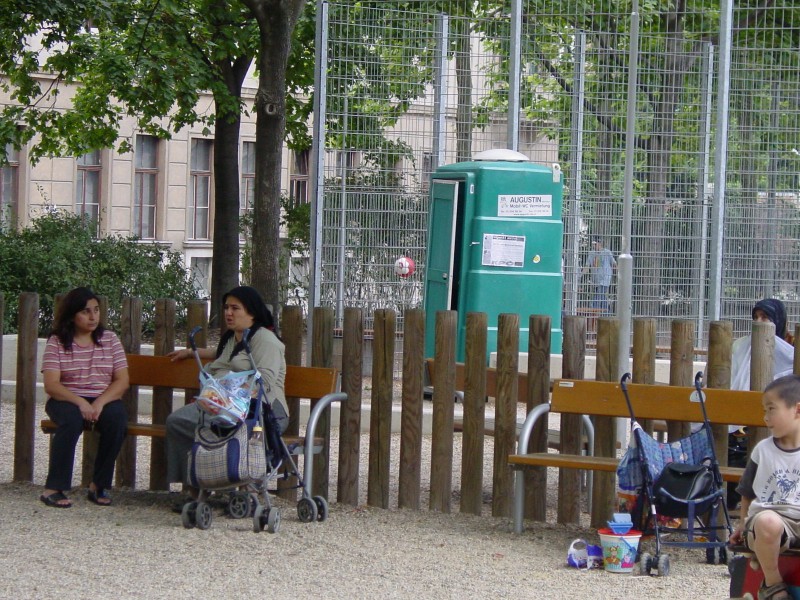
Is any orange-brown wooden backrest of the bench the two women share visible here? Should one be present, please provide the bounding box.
[126,354,338,400]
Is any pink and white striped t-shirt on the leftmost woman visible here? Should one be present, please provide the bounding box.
[42,330,128,398]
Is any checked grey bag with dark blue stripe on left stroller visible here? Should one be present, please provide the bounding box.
[189,423,267,489]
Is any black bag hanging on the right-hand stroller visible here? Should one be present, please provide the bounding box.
[653,462,719,517]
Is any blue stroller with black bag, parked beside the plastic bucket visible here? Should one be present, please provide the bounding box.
[617,373,732,577]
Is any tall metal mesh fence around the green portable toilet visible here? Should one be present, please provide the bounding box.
[315,0,800,346]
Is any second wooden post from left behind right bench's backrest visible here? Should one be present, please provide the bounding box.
[591,318,620,528]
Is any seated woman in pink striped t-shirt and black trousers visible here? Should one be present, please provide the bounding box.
[39,287,128,508]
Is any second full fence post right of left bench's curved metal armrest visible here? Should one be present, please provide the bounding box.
[367,309,397,508]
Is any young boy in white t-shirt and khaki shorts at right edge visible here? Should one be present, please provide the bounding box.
[730,375,800,600]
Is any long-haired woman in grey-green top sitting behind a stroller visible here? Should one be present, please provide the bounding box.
[166,286,289,498]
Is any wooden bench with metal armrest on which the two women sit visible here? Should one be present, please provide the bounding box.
[40,354,346,486]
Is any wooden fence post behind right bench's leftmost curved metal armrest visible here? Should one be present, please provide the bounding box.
[522,315,551,521]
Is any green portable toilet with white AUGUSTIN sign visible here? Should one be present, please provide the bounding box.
[424,150,564,361]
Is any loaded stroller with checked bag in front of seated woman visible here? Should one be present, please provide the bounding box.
[181,327,328,533]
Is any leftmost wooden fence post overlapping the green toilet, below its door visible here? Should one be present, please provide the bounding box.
[429,310,458,513]
